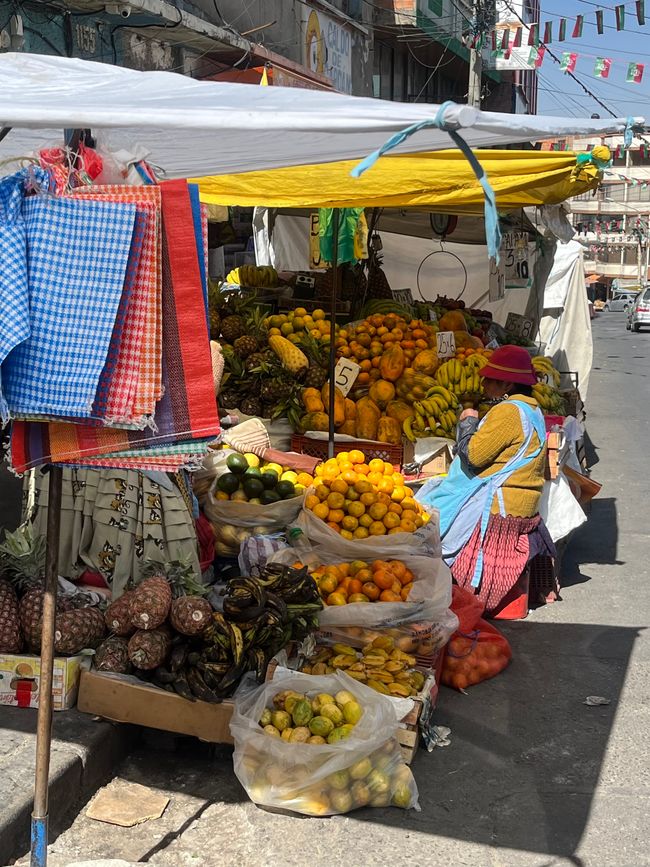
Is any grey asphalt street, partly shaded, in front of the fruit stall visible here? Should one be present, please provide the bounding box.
[10,313,650,867]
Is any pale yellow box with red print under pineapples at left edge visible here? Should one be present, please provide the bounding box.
[0,653,90,710]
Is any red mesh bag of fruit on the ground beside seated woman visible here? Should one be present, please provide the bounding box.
[441,587,512,689]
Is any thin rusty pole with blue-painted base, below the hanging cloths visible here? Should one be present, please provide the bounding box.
[30,467,63,867]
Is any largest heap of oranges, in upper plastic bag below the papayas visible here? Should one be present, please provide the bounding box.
[305,449,428,539]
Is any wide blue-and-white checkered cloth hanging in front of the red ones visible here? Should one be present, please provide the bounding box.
[2,196,136,418]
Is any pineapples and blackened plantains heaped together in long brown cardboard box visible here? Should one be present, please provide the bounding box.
[95,566,322,702]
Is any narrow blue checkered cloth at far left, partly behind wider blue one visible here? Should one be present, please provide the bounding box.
[0,168,48,424]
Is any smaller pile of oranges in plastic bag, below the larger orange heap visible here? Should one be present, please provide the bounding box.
[311,560,414,605]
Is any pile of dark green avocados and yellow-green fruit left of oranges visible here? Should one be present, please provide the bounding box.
[215,452,314,506]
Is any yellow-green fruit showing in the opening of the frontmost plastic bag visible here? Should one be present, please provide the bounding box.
[259,690,363,745]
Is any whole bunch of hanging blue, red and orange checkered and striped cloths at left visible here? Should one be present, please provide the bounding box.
[0,167,220,472]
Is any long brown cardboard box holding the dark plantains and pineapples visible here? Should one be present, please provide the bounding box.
[77,671,234,744]
